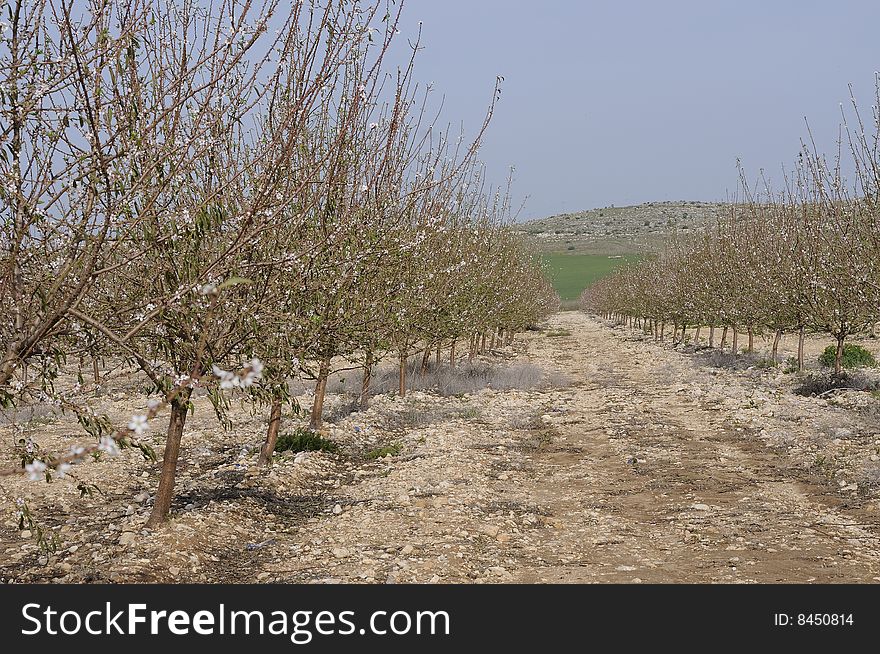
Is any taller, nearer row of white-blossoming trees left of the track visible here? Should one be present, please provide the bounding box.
[0,0,557,527]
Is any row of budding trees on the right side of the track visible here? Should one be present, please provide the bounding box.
[582,75,880,375]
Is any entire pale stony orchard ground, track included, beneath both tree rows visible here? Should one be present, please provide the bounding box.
[0,312,880,583]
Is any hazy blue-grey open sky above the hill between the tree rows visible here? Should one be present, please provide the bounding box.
[401,0,880,219]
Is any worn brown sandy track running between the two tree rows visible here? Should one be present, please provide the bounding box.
[515,312,880,582]
